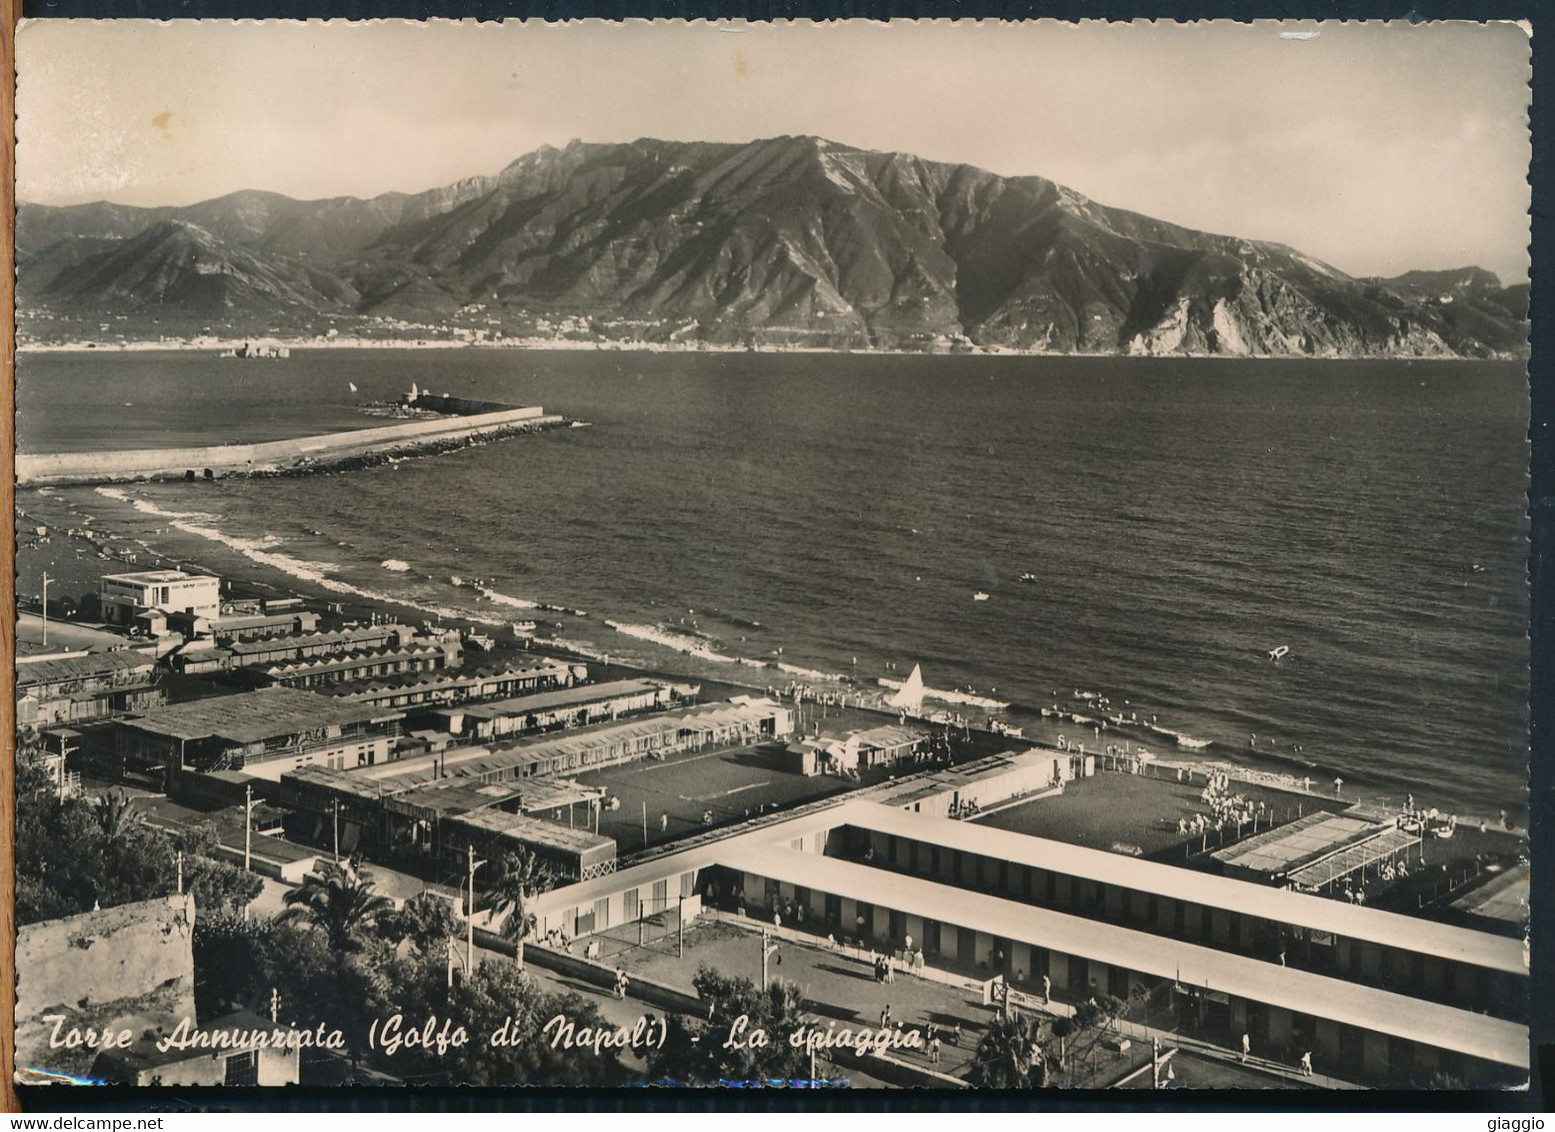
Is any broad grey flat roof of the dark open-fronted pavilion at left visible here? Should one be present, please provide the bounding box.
[126,687,401,743]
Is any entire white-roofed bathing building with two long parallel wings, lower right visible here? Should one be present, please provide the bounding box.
[533,799,1529,1087]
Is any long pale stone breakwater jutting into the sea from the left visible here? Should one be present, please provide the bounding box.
[16,406,564,485]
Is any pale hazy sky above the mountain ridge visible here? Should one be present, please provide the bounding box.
[17,20,1529,281]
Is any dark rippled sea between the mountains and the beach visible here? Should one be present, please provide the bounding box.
[17,350,1527,812]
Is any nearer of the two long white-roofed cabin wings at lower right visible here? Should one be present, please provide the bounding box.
[720,841,1529,1084]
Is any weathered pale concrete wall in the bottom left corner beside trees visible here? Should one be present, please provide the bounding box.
[16,894,194,1074]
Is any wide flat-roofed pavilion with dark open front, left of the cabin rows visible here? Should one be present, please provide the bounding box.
[117,687,404,782]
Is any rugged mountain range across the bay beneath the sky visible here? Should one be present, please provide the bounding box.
[16,137,1529,358]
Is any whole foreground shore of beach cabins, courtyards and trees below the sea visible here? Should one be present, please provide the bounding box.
[6,390,1530,1088]
